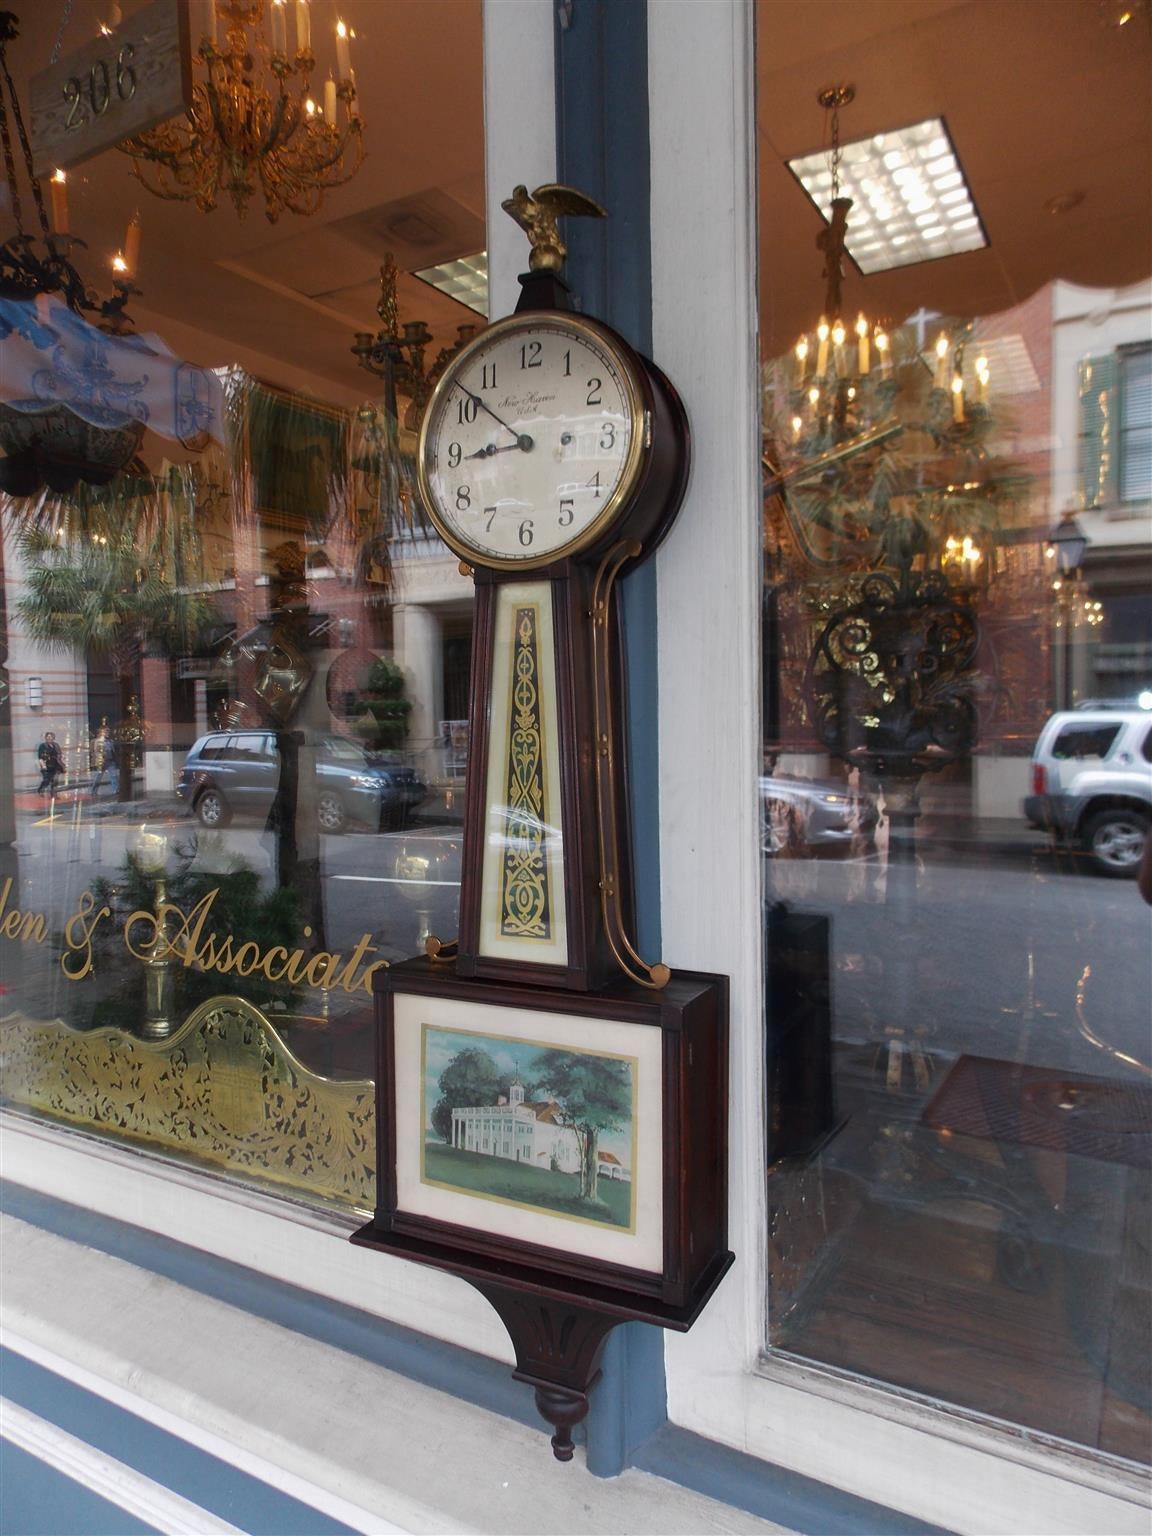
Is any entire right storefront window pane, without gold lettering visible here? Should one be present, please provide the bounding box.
[760,3,1152,1461]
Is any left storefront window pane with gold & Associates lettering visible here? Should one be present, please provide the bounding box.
[0,0,484,1207]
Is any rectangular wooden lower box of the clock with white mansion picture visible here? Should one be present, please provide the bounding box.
[353,958,733,1329]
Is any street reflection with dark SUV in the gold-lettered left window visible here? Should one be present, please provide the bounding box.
[5,360,467,1077]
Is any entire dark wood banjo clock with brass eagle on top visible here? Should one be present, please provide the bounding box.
[353,186,733,1461]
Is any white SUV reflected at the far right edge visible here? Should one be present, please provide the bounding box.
[1025,705,1152,876]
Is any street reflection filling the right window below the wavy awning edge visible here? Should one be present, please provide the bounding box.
[760,284,1152,1459]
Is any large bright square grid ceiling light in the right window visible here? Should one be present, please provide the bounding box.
[788,117,988,275]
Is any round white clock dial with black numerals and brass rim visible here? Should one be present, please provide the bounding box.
[421,315,644,565]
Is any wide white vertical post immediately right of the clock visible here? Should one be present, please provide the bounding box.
[648,0,765,1394]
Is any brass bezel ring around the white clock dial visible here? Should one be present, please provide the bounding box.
[416,310,651,571]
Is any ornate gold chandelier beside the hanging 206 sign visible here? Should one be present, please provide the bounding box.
[120,0,364,224]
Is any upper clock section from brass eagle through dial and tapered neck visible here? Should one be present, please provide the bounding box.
[418,187,690,991]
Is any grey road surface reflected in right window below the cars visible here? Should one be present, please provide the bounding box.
[766,836,1152,1074]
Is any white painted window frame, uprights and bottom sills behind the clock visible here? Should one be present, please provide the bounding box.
[3,0,1147,1536]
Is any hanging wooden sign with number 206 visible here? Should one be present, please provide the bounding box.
[31,0,192,177]
